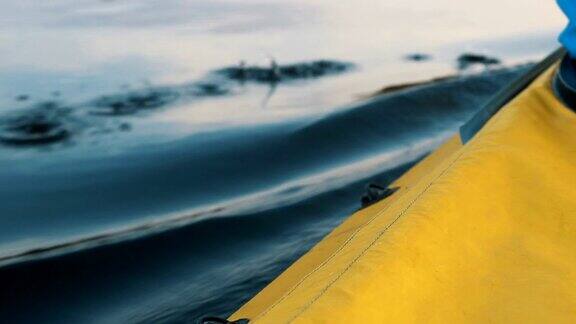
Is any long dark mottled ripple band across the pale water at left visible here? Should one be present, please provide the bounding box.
[0,60,354,153]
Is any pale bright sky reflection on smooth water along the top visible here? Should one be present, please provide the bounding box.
[0,0,563,116]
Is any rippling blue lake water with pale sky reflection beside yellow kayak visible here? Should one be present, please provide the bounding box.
[0,0,565,323]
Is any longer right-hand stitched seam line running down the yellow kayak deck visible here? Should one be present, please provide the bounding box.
[287,148,466,323]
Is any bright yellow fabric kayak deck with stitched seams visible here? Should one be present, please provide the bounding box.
[230,48,576,324]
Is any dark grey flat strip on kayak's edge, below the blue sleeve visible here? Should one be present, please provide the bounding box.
[460,47,566,144]
